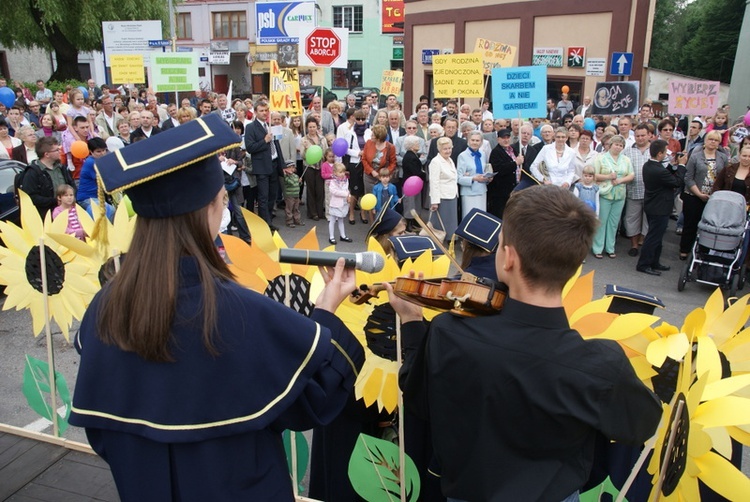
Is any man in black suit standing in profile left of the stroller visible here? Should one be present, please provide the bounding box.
[635,139,684,275]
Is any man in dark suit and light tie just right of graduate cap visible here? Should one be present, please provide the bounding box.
[245,100,284,231]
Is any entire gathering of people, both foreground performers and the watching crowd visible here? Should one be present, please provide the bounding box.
[5,75,750,502]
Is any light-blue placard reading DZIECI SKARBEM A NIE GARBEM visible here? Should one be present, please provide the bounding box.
[492,66,547,118]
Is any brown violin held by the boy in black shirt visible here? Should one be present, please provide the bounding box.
[349,274,508,317]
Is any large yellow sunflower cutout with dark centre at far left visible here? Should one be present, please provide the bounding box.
[0,191,99,341]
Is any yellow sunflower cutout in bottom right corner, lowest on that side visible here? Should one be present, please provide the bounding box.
[648,324,750,502]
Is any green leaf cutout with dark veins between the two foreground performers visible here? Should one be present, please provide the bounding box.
[349,434,420,502]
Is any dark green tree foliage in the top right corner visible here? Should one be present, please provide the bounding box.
[649,0,746,82]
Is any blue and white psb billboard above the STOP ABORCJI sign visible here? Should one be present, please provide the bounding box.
[255,2,315,45]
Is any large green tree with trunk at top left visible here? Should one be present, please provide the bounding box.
[0,0,168,80]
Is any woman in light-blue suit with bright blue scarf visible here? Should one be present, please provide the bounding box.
[456,130,492,218]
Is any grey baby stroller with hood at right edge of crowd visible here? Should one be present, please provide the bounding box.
[677,190,748,296]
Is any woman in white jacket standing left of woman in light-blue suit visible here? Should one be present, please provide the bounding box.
[429,137,458,241]
